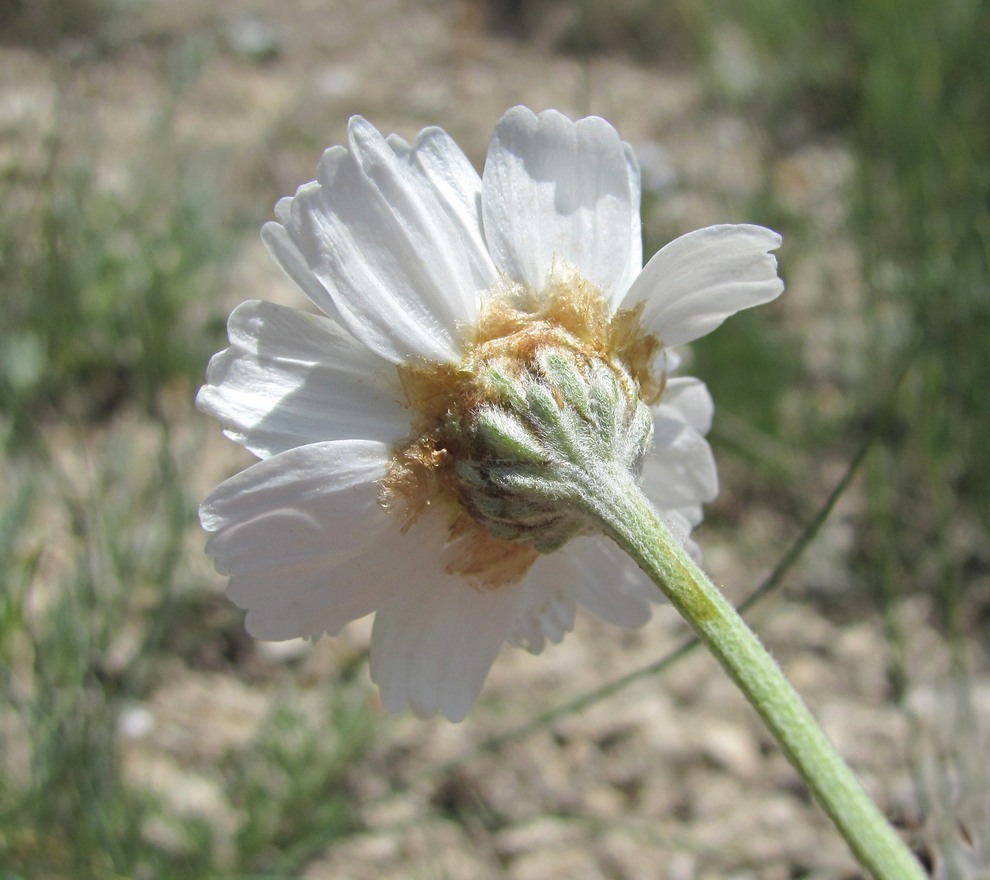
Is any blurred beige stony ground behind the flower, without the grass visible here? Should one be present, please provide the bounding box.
[0,0,990,880]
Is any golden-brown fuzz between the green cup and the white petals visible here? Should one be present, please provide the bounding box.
[380,270,666,589]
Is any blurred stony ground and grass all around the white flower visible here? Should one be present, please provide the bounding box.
[0,0,990,880]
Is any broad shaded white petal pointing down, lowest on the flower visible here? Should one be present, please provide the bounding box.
[371,536,522,721]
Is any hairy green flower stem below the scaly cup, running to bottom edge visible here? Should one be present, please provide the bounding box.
[572,468,927,880]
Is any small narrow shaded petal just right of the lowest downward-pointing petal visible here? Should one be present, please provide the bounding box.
[509,556,578,654]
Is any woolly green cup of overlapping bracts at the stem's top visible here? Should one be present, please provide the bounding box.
[454,346,653,553]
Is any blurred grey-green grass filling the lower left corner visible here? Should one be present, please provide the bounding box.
[0,418,374,880]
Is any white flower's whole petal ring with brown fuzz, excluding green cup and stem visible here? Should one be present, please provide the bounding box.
[197,107,783,721]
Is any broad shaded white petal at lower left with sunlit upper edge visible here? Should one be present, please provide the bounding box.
[200,440,404,639]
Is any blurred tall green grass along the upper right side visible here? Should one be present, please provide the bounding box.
[696,0,990,630]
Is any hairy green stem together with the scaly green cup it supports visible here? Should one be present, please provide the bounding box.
[468,340,926,880]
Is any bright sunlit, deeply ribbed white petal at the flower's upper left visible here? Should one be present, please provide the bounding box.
[280,117,492,363]
